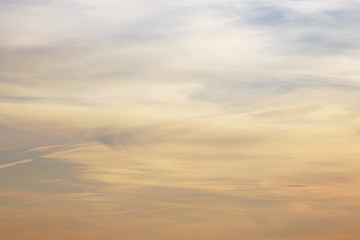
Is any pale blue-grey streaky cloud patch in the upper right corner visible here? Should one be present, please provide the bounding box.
[224,2,360,57]
